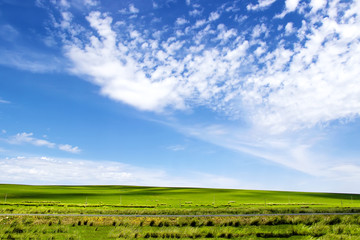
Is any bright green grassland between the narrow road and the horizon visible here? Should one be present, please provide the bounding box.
[0,184,360,214]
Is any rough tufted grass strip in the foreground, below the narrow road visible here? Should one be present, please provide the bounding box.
[0,215,360,239]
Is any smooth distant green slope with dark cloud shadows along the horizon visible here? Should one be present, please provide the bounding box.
[0,184,360,204]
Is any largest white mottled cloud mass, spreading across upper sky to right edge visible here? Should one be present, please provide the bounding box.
[60,1,360,134]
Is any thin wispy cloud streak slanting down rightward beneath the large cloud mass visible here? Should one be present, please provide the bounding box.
[174,124,360,186]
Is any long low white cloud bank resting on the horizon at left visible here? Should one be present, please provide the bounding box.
[0,156,243,188]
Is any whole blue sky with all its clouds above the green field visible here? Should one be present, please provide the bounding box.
[0,0,360,192]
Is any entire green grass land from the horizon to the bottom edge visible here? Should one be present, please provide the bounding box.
[0,184,360,239]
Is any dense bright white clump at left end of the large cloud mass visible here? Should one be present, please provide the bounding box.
[66,12,184,111]
